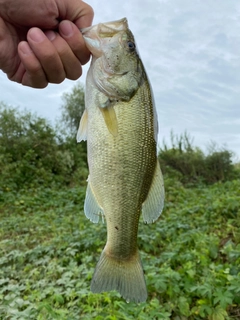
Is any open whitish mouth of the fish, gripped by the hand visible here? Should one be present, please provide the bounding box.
[80,18,128,58]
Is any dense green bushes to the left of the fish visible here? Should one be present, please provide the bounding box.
[0,104,87,189]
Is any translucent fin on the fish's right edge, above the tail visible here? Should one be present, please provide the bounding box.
[142,161,164,223]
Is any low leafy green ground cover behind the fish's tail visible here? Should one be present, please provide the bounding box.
[0,178,240,320]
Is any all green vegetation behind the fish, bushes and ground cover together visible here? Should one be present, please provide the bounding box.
[0,85,240,320]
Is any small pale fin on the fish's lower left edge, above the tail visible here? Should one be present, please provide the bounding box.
[84,179,104,223]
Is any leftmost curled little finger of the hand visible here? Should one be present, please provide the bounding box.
[17,41,48,88]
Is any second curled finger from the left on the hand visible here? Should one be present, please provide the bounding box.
[27,28,66,83]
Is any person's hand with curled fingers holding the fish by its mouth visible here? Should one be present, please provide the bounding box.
[0,0,93,88]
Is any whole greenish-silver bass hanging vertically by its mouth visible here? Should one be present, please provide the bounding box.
[77,18,164,303]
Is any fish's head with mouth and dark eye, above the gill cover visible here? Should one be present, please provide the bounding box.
[81,18,141,87]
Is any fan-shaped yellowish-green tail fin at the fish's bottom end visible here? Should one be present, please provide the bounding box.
[91,250,147,303]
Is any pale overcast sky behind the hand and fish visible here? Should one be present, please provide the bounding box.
[0,0,240,160]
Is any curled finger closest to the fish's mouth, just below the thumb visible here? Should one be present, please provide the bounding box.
[59,20,90,65]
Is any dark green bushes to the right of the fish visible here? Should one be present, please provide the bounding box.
[159,132,237,185]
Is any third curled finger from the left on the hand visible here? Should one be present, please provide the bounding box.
[45,30,82,80]
